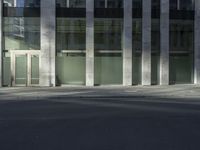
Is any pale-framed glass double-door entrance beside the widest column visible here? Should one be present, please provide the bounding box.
[11,51,40,86]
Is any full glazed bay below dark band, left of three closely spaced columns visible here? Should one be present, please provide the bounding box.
[94,18,123,85]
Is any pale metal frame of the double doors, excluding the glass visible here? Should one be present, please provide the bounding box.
[10,50,41,86]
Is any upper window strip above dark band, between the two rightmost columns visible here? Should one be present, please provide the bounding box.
[170,0,195,10]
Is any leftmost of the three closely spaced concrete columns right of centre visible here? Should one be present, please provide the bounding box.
[123,0,132,86]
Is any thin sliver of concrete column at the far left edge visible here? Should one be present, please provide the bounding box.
[0,1,3,87]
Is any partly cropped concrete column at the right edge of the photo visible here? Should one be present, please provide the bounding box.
[194,0,200,84]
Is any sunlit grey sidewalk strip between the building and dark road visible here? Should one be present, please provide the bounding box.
[0,85,200,100]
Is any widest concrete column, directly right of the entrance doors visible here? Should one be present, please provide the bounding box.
[40,0,56,86]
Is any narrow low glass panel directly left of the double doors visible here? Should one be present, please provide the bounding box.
[3,53,11,86]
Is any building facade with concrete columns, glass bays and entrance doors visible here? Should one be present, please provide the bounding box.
[0,0,200,86]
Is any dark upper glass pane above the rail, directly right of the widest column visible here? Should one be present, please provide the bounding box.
[56,18,86,51]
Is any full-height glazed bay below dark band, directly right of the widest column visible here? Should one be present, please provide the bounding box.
[56,18,86,85]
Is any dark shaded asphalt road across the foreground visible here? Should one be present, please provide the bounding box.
[0,86,200,150]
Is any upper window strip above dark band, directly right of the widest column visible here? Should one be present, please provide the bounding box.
[56,0,86,8]
